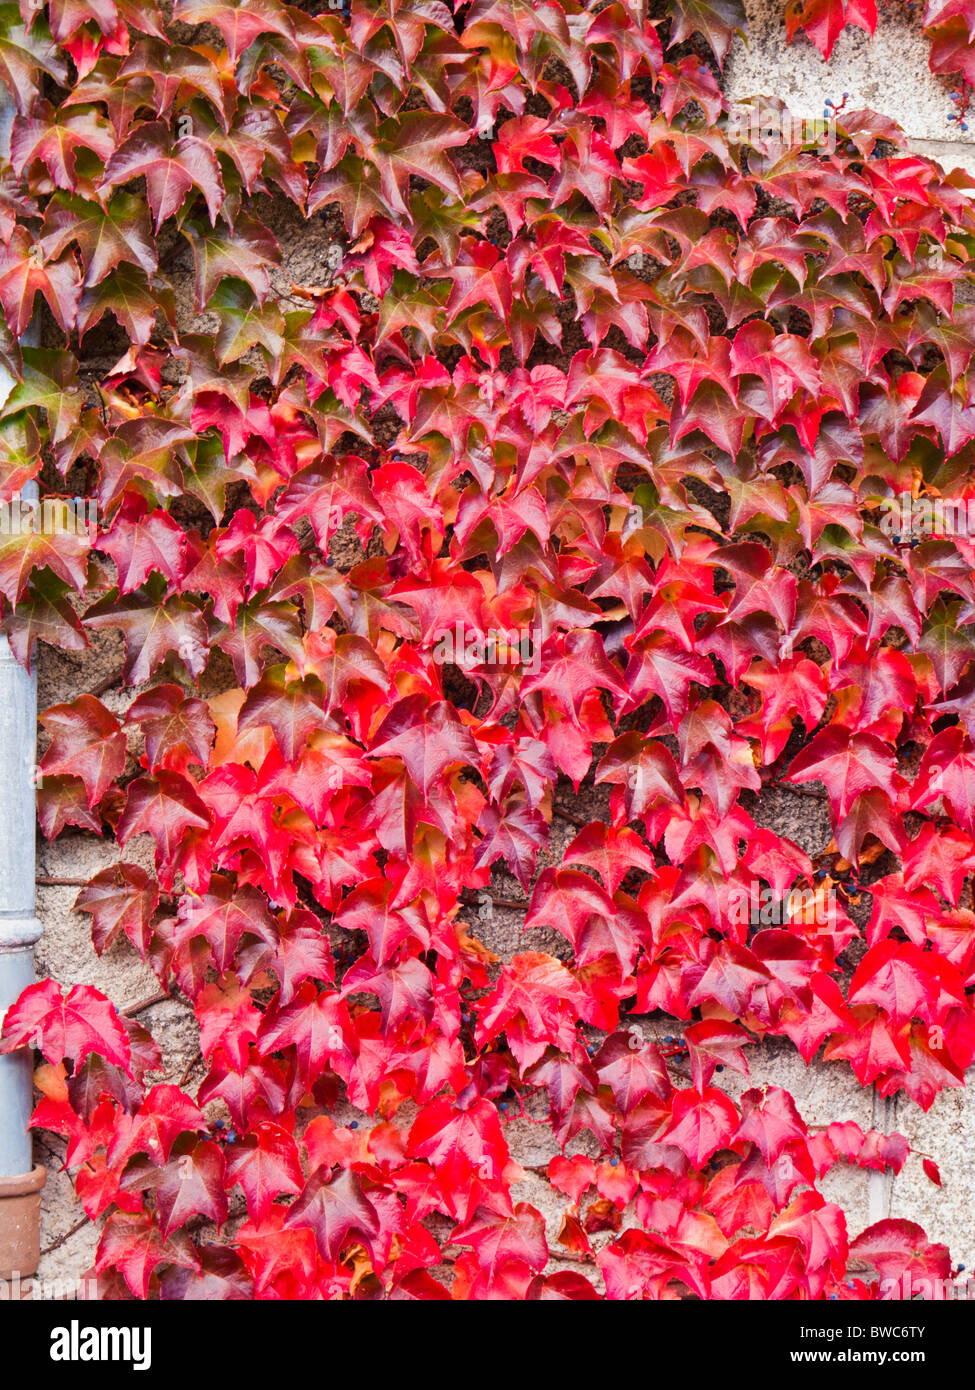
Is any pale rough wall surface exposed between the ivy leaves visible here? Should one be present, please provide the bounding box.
[17,0,975,1282]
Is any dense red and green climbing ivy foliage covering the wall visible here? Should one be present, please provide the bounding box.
[0,0,975,1300]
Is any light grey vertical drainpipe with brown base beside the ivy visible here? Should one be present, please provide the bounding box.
[0,93,46,1297]
